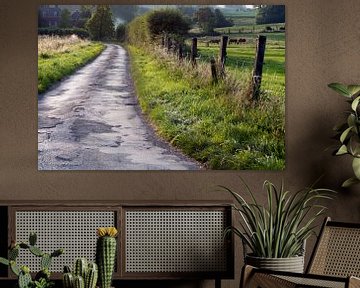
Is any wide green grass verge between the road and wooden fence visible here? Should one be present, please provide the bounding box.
[129,46,285,170]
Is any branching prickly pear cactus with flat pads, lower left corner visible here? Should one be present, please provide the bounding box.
[0,233,64,288]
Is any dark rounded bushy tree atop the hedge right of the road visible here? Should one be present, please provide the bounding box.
[147,9,190,38]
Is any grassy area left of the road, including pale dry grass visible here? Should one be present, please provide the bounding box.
[38,36,105,93]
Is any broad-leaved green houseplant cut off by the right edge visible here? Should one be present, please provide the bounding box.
[328,83,360,187]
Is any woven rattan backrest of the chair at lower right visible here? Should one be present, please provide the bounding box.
[307,218,360,277]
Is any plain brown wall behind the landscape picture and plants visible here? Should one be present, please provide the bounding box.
[0,0,360,287]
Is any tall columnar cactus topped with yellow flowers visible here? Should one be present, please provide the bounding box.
[96,227,118,288]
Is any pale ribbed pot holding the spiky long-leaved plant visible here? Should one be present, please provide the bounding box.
[245,255,304,273]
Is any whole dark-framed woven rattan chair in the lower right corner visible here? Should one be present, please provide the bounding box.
[240,218,360,288]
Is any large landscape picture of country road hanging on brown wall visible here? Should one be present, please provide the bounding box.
[38,5,286,170]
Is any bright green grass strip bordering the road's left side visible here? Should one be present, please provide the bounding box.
[38,42,105,93]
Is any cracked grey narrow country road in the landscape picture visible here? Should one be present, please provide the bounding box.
[38,44,200,170]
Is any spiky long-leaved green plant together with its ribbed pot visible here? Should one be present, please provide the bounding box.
[221,181,334,273]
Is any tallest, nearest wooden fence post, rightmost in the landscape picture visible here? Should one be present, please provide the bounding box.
[252,36,266,101]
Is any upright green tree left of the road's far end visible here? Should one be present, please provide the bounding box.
[86,5,114,40]
